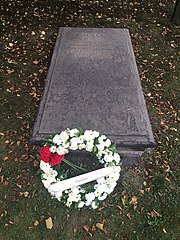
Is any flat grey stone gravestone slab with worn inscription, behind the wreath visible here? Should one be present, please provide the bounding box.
[30,28,155,160]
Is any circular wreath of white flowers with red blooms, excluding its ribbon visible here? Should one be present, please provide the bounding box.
[40,128,121,209]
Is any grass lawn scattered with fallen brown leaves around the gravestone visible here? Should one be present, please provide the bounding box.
[0,0,180,240]
